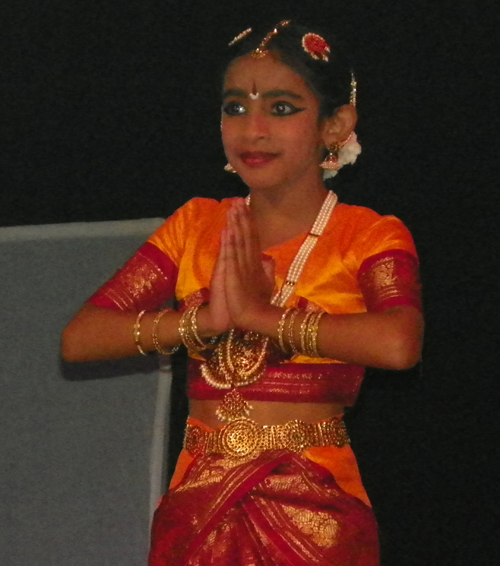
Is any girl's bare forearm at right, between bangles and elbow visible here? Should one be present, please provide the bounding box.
[240,305,423,369]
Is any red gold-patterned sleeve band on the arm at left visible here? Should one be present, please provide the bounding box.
[89,242,178,311]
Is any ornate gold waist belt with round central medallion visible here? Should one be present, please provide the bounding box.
[184,417,350,458]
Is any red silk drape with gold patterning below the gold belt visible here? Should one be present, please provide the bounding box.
[149,440,379,566]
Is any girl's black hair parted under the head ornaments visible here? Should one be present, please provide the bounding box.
[226,21,353,119]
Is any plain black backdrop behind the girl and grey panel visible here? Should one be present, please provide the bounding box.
[0,0,500,566]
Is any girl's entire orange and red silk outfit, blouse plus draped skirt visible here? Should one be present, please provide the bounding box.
[91,199,420,566]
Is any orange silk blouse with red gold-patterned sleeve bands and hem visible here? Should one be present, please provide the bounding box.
[90,198,421,405]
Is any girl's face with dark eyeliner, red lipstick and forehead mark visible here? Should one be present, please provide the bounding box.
[221,54,324,193]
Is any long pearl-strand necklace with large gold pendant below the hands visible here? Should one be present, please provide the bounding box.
[201,191,338,423]
